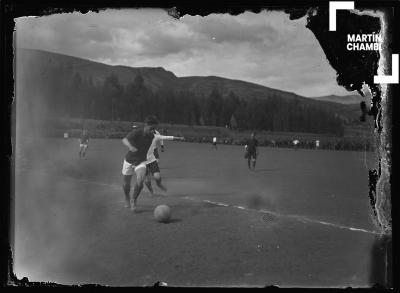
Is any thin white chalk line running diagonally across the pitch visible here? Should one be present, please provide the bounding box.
[15,169,380,235]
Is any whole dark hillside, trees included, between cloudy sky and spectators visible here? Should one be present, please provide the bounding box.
[16,49,366,133]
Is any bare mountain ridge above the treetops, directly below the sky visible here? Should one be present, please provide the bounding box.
[17,48,363,104]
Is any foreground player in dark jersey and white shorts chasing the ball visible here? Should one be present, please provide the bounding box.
[122,116,183,211]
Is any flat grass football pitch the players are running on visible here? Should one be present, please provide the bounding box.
[13,139,379,287]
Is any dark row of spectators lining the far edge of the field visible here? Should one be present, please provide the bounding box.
[40,117,374,151]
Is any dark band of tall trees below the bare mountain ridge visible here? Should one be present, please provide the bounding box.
[31,68,343,135]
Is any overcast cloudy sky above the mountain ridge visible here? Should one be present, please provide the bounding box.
[16,9,350,97]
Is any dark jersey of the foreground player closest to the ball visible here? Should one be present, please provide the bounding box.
[125,128,154,165]
